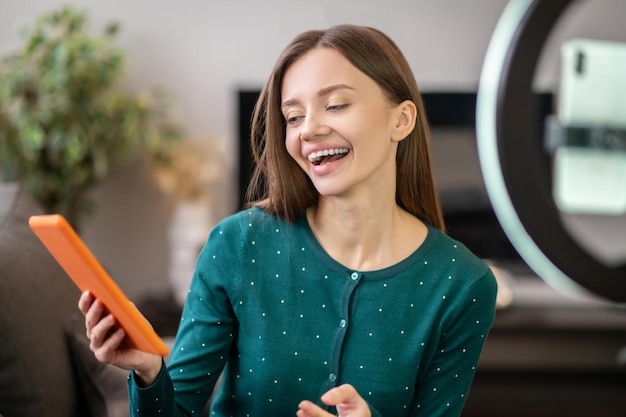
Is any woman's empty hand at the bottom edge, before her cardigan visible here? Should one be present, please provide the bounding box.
[296,384,372,417]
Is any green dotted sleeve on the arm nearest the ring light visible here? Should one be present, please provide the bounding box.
[414,269,497,417]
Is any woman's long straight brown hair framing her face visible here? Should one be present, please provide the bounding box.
[247,25,444,230]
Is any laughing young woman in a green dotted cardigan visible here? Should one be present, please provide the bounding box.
[79,25,496,417]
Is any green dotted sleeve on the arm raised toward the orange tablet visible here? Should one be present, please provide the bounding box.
[128,216,242,417]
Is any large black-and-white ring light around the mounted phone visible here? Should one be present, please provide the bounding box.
[476,0,626,302]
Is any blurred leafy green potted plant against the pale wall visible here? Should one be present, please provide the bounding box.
[0,7,182,228]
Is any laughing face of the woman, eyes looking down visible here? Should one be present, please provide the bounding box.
[281,47,403,200]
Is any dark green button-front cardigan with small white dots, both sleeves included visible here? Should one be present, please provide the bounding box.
[129,209,496,417]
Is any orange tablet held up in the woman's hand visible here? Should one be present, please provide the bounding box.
[28,214,168,356]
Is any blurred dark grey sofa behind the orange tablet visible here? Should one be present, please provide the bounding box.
[0,184,128,417]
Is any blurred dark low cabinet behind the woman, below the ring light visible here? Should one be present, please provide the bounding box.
[462,275,626,417]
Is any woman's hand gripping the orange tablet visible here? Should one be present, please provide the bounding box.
[78,291,163,386]
